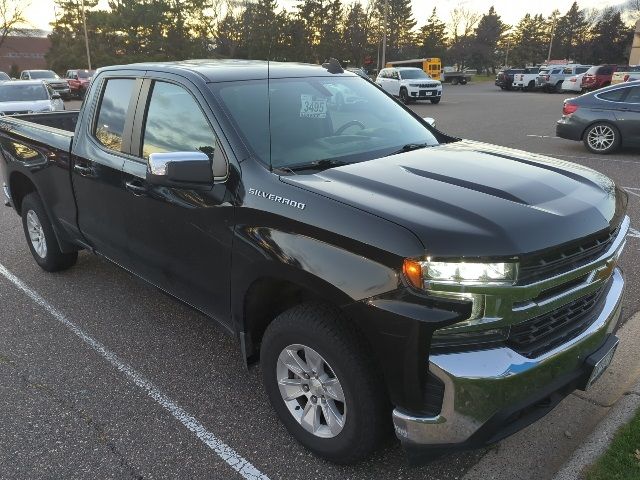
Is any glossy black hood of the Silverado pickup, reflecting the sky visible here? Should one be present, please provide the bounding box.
[282,141,626,257]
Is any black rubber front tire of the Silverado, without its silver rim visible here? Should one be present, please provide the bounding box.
[260,303,392,464]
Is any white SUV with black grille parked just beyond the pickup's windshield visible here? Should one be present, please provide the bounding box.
[376,67,442,104]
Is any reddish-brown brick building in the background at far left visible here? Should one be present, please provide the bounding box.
[0,30,51,73]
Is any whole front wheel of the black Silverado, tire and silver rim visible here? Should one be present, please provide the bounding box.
[260,303,390,464]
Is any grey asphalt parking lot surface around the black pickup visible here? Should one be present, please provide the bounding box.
[0,83,640,479]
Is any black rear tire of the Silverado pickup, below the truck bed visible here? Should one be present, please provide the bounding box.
[20,193,78,272]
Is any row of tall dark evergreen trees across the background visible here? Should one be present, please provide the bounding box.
[47,0,637,73]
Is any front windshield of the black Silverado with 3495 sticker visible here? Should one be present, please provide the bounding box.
[211,75,438,169]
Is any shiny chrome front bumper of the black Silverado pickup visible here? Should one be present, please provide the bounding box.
[393,232,628,450]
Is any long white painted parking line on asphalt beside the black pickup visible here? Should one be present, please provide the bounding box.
[0,263,269,480]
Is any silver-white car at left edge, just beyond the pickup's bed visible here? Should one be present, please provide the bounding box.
[0,80,64,115]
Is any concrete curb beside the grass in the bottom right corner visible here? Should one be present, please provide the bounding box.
[553,381,640,480]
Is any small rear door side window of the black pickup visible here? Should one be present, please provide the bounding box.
[93,78,135,152]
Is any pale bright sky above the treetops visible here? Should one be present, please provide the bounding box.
[23,0,624,30]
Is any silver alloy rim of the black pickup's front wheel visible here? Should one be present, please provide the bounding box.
[276,345,347,438]
